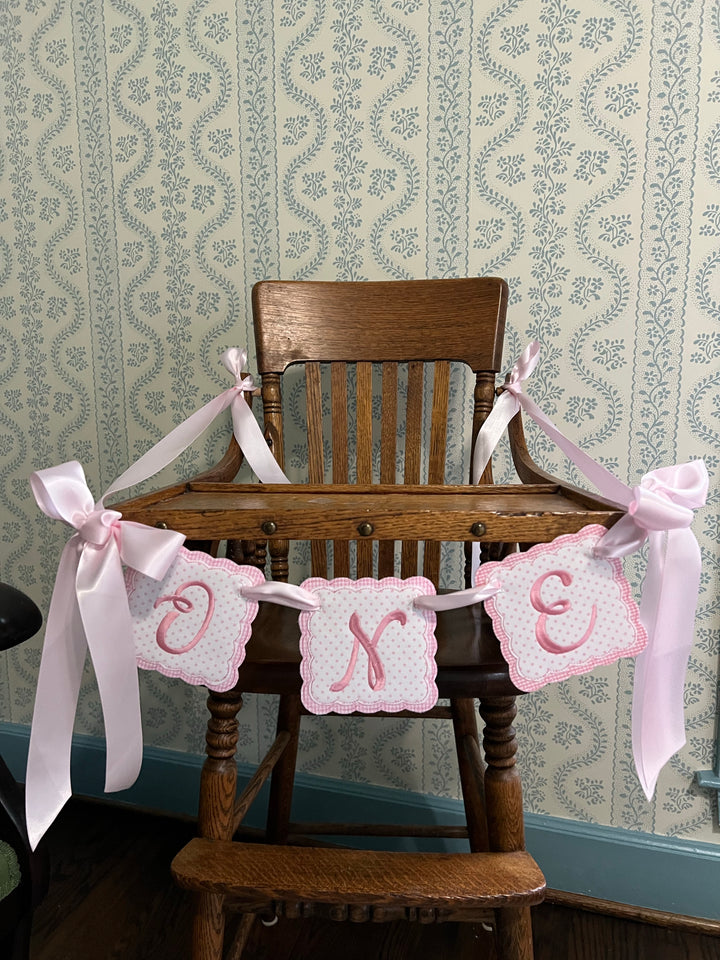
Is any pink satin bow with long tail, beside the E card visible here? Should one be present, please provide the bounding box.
[596,460,708,800]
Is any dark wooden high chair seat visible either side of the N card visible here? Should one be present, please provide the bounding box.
[239,603,521,697]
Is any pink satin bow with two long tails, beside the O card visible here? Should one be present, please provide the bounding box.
[25,460,185,849]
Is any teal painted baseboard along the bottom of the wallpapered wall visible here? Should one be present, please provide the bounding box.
[0,723,720,920]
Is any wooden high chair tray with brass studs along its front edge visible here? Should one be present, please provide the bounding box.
[113,484,622,544]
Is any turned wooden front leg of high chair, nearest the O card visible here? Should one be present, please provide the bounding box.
[192,689,242,960]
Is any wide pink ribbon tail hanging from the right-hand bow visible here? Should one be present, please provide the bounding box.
[632,529,701,800]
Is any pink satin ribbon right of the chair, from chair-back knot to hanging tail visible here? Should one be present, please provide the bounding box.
[473,341,708,800]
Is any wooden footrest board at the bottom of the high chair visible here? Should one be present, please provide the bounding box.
[172,838,545,913]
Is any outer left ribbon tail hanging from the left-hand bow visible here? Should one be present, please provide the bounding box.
[25,536,87,850]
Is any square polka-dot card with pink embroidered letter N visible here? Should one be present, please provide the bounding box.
[299,577,438,713]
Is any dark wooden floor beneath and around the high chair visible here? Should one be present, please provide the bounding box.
[31,801,720,960]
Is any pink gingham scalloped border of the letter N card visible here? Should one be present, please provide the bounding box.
[298,577,438,715]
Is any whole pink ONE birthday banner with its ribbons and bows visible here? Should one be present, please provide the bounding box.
[26,343,708,848]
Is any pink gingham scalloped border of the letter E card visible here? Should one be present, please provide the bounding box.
[475,523,648,693]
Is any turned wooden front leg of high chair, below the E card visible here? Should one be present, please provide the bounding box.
[480,697,533,960]
